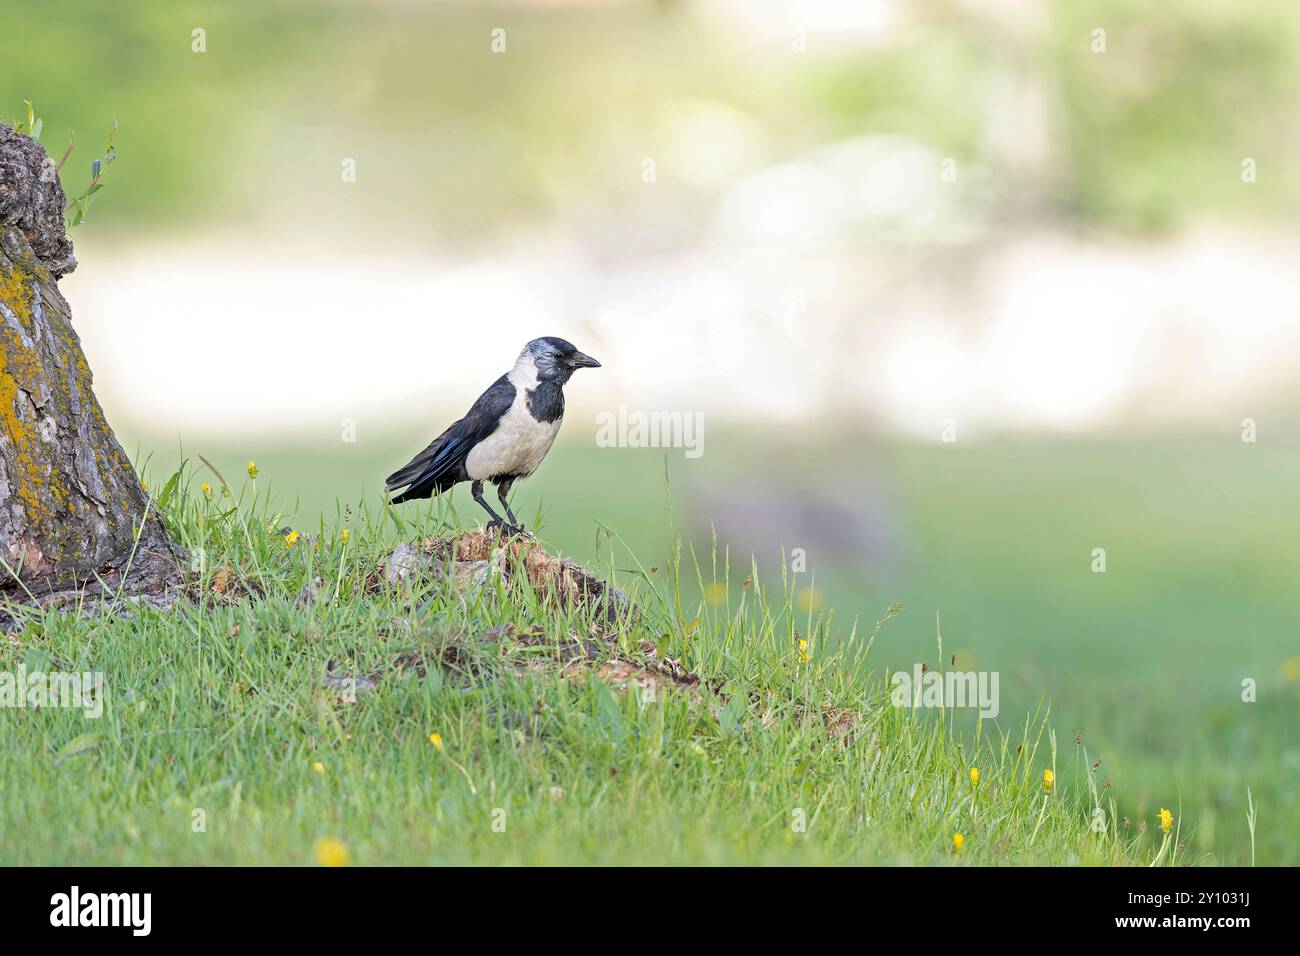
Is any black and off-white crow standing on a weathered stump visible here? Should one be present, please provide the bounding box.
[385,336,601,535]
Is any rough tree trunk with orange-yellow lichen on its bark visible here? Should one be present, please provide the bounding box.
[0,126,182,624]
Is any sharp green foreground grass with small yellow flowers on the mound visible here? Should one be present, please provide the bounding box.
[0,455,1186,864]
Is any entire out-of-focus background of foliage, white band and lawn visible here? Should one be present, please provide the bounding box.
[0,0,1300,864]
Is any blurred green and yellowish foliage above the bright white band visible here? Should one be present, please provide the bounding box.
[0,0,1300,241]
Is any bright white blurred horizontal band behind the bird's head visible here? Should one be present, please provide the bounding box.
[64,213,1300,438]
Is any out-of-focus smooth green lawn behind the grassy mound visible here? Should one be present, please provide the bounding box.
[86,421,1300,865]
